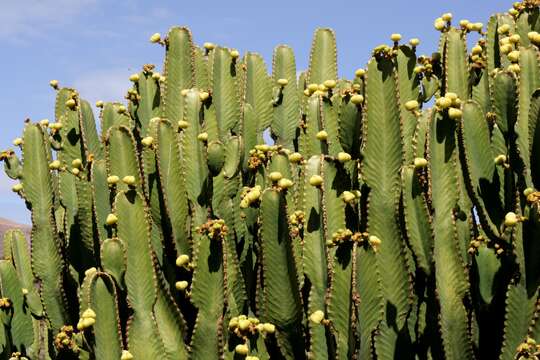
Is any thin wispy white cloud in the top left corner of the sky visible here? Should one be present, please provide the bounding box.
[0,0,100,42]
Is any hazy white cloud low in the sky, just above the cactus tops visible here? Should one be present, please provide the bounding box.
[73,69,130,103]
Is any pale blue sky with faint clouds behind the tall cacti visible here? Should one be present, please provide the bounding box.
[0,0,512,223]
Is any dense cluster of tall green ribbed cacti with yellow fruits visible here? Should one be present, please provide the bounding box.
[0,0,540,360]
